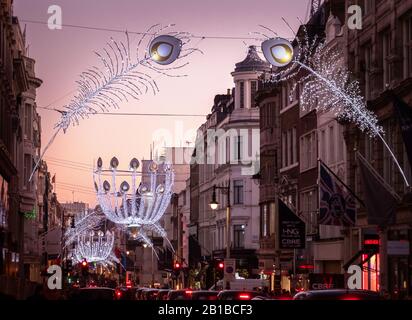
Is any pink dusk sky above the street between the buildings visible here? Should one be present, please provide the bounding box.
[14,0,310,206]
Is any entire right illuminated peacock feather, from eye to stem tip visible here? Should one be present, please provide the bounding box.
[257,20,409,186]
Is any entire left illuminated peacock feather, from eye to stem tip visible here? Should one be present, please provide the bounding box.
[29,24,201,181]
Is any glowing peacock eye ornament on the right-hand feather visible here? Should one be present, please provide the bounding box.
[262,38,294,67]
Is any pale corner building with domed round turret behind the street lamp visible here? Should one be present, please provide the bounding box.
[189,46,270,285]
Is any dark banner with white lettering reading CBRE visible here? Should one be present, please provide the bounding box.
[278,199,306,249]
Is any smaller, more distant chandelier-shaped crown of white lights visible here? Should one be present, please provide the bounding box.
[74,230,114,263]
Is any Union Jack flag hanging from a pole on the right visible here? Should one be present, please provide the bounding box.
[319,161,356,226]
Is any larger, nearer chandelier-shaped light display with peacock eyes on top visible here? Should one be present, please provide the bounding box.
[94,158,174,228]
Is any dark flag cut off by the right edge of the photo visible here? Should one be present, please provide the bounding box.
[393,96,412,165]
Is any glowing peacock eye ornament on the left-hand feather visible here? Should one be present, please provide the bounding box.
[149,35,183,65]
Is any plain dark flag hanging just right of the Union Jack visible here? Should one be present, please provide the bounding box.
[357,152,399,226]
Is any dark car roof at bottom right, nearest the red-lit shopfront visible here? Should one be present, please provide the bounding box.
[293,289,382,300]
